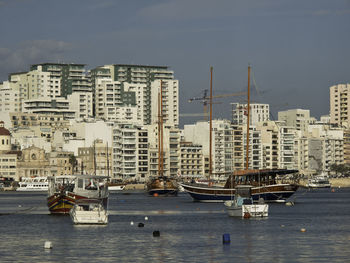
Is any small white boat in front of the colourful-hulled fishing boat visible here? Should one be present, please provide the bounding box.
[69,199,108,225]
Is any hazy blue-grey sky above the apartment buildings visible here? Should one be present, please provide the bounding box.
[0,0,350,126]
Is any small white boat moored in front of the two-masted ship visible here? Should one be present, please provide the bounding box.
[224,185,269,218]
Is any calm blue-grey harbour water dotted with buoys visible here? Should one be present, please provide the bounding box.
[0,188,350,262]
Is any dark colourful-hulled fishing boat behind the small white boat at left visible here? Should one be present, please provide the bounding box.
[47,175,109,214]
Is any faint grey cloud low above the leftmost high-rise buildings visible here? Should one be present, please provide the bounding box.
[0,39,72,80]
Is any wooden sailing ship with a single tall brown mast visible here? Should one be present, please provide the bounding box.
[146,80,179,196]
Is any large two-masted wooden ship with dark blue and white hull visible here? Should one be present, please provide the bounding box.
[180,66,298,202]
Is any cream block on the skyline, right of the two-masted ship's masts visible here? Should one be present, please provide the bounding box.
[278,109,316,131]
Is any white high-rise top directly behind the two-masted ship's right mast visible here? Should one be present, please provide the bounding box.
[231,103,270,125]
